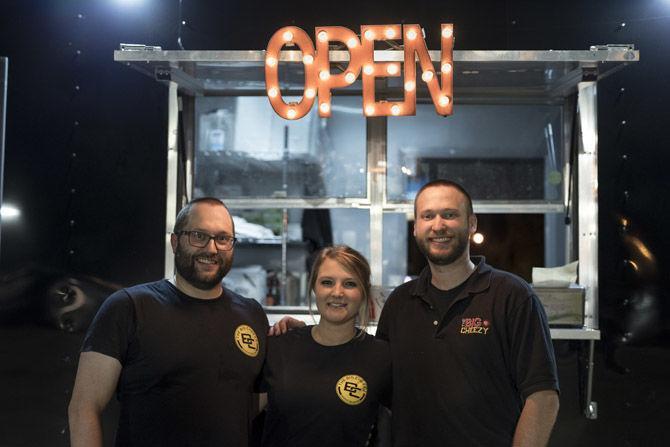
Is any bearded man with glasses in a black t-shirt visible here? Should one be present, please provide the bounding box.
[69,198,268,447]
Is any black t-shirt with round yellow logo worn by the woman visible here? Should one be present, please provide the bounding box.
[261,326,391,447]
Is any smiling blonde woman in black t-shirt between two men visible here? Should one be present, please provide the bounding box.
[262,246,391,447]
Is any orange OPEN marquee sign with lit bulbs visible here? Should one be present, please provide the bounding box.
[265,24,454,120]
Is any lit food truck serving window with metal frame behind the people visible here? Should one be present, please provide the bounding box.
[114,31,639,418]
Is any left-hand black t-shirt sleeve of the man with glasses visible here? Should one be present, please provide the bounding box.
[81,290,135,364]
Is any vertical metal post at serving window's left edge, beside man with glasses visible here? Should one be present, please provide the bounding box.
[165,81,179,278]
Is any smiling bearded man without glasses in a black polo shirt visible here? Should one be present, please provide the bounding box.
[377,180,559,447]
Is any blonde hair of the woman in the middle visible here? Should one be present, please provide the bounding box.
[307,245,372,329]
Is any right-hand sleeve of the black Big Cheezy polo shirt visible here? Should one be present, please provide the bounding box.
[510,294,559,400]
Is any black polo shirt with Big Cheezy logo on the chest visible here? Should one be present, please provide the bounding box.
[377,257,558,447]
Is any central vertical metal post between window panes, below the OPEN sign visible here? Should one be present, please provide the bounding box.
[366,116,387,286]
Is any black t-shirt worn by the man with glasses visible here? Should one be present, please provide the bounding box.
[82,280,268,447]
